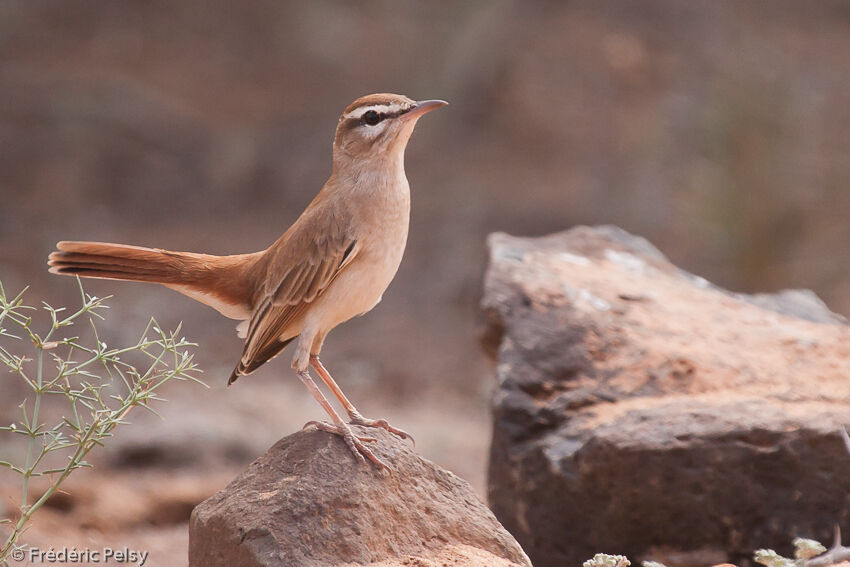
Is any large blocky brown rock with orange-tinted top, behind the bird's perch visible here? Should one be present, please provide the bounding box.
[482,227,850,567]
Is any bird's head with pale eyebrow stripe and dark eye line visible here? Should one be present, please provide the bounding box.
[334,93,448,167]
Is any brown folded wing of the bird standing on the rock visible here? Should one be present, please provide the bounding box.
[235,209,357,369]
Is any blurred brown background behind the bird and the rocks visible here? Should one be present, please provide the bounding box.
[0,0,850,565]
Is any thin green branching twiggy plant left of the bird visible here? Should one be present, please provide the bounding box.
[0,278,206,565]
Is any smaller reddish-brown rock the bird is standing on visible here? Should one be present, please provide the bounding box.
[189,429,530,567]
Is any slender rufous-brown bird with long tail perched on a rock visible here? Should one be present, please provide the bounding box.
[48,93,448,469]
